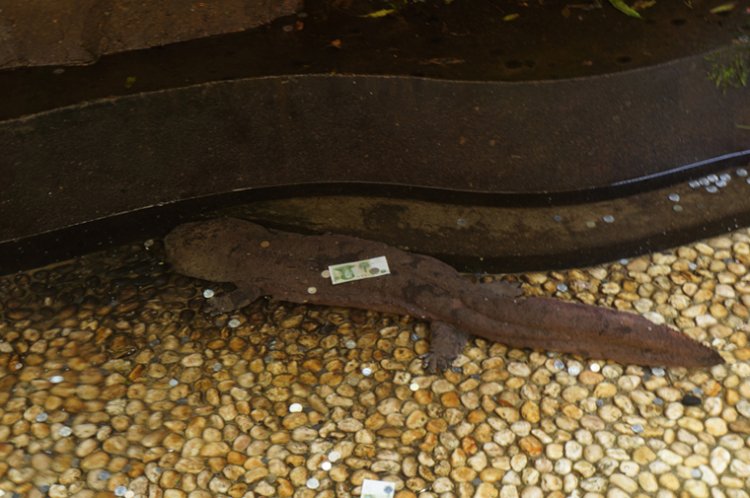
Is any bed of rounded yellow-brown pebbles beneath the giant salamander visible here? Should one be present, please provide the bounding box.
[0,229,750,498]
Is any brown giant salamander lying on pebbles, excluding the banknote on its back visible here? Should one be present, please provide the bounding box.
[164,218,722,370]
